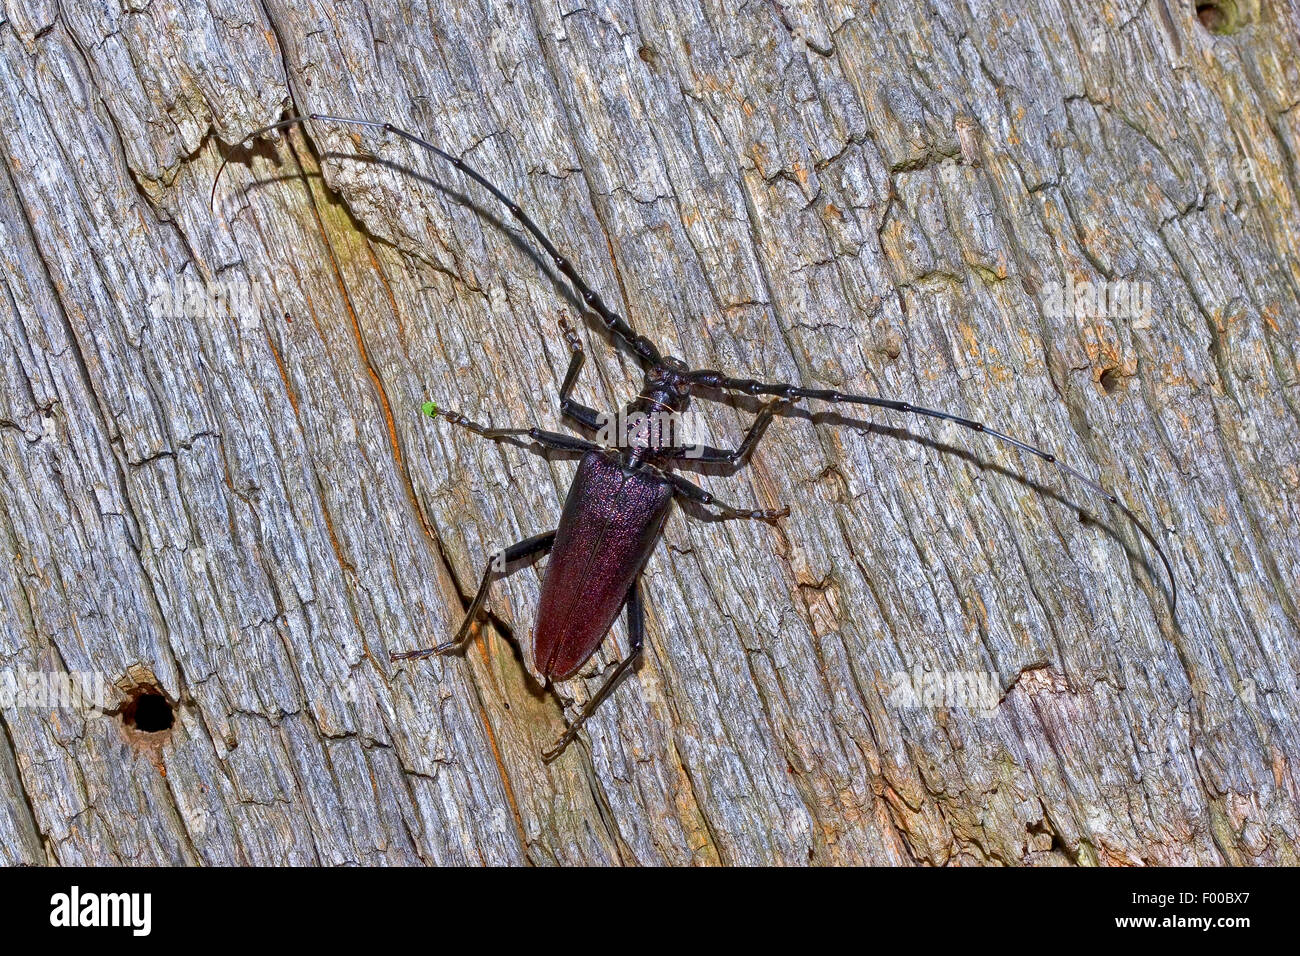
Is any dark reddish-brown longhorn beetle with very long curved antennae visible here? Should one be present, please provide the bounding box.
[208,113,1178,762]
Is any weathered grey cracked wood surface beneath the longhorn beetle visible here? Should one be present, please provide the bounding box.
[0,0,1300,864]
